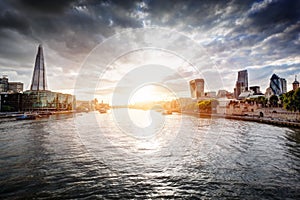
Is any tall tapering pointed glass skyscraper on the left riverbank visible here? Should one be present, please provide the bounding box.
[30,44,47,90]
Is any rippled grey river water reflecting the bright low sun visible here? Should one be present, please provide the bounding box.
[0,110,300,199]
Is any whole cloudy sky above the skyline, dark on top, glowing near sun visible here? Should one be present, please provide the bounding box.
[0,0,300,100]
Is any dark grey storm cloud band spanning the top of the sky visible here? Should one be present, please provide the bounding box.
[0,0,300,51]
